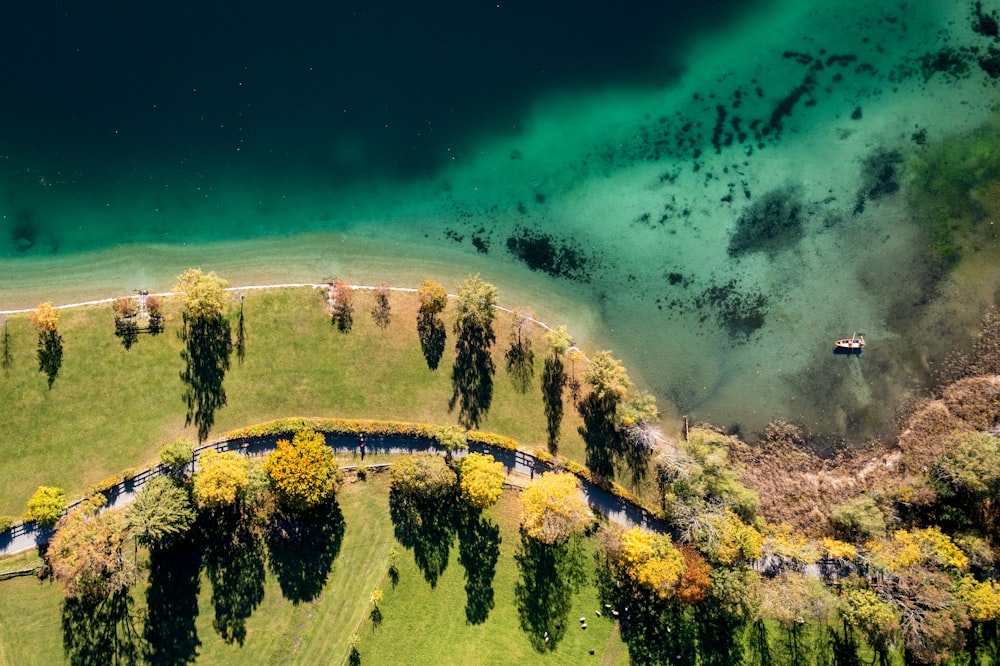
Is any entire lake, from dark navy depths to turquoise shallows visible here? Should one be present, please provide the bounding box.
[0,0,998,440]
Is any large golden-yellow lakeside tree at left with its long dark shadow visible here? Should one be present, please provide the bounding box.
[174,268,233,442]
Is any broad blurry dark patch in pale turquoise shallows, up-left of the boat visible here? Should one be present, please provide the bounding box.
[728,188,805,257]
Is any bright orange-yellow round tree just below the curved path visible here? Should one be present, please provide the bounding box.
[264,430,339,511]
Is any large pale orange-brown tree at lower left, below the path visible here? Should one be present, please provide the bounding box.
[46,503,133,599]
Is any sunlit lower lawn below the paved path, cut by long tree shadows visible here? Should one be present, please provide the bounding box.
[0,474,628,666]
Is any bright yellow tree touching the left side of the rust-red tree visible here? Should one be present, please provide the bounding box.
[619,527,687,599]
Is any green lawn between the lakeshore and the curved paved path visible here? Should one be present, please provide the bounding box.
[0,289,583,516]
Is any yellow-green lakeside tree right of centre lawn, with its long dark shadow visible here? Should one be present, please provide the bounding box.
[448,274,497,428]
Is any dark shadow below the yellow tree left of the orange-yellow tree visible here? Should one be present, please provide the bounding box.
[199,509,265,645]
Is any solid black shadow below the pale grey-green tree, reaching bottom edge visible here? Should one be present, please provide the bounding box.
[143,537,202,666]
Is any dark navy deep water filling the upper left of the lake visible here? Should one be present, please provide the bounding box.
[0,0,749,178]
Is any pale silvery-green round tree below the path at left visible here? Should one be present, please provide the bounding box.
[125,476,196,549]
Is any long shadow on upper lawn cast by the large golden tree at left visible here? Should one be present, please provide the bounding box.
[180,314,233,442]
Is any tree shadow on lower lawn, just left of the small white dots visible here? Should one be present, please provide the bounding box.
[514,532,586,652]
